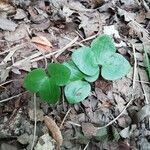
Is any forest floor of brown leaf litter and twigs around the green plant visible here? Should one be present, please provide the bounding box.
[0,0,150,150]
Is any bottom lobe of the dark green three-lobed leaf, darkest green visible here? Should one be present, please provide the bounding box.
[39,78,61,104]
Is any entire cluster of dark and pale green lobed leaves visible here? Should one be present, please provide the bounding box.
[23,35,131,104]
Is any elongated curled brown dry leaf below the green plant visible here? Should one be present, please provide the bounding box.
[44,116,63,146]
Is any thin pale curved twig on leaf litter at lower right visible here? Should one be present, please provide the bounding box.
[97,99,134,130]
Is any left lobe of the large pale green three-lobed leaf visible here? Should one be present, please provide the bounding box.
[72,47,99,76]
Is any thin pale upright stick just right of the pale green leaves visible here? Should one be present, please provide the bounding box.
[132,44,137,89]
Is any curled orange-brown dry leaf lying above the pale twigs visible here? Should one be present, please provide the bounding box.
[31,36,53,51]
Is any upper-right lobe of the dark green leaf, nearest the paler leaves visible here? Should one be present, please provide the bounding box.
[47,63,71,86]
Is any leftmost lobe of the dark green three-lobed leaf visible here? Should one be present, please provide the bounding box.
[23,69,49,93]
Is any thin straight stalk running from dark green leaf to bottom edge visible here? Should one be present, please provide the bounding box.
[31,93,37,150]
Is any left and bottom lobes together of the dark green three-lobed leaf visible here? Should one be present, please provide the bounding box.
[23,69,60,104]
